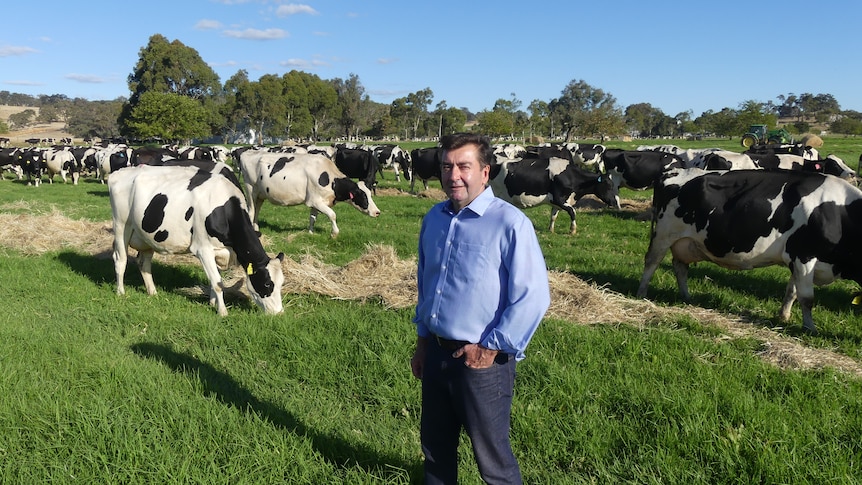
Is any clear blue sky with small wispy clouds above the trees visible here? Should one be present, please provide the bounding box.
[0,0,862,116]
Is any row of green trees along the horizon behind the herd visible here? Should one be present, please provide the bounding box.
[0,34,862,143]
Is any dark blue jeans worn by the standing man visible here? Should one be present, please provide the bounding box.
[420,338,522,485]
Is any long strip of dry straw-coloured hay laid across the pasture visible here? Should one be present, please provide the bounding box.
[0,205,862,376]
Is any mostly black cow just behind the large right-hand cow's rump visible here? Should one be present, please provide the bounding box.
[602,148,682,190]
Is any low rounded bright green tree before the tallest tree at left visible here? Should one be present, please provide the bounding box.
[127,92,209,143]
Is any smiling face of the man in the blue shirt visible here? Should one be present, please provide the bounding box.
[440,144,491,211]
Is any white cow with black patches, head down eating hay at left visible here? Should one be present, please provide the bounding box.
[108,164,284,316]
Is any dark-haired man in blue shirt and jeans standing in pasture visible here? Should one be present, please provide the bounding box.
[410,134,550,484]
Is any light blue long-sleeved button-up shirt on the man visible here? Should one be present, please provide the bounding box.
[413,188,551,360]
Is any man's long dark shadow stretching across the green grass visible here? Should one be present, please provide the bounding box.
[131,342,422,483]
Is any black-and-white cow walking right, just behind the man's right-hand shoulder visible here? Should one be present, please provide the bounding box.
[489,158,620,234]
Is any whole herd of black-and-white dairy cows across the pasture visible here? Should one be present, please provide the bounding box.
[0,138,862,333]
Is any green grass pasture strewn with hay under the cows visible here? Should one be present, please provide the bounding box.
[0,138,862,484]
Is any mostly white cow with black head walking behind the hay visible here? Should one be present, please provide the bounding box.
[239,150,380,237]
